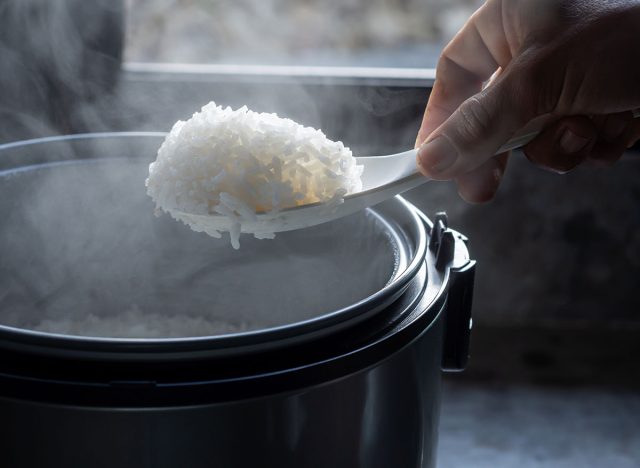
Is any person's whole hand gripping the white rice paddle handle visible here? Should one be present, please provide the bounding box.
[416,0,640,203]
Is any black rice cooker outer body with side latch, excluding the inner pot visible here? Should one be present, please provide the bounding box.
[0,133,475,468]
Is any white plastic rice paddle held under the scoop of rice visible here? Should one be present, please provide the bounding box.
[180,109,640,234]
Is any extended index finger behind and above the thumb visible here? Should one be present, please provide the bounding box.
[416,1,512,147]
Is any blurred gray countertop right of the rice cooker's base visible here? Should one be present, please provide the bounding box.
[438,376,640,468]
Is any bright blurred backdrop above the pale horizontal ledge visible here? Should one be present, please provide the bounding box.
[125,0,483,66]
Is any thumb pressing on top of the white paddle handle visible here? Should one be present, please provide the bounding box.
[417,70,537,180]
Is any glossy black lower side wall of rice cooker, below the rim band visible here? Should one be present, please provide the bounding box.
[0,314,442,468]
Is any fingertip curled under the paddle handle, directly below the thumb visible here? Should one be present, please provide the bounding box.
[456,153,509,203]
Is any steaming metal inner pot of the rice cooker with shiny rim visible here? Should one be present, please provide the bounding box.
[0,134,424,352]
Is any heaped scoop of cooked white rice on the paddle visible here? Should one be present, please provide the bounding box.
[146,102,363,249]
